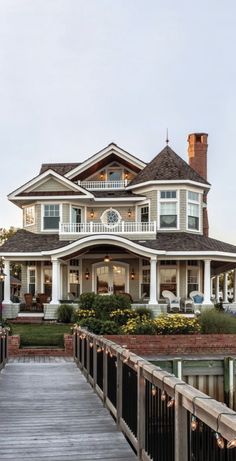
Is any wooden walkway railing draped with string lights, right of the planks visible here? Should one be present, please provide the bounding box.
[74,327,236,461]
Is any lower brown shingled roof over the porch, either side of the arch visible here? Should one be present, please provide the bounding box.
[0,229,236,255]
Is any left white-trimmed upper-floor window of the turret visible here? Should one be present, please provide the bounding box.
[160,190,178,229]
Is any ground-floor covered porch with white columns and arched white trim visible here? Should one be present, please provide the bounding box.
[3,235,236,319]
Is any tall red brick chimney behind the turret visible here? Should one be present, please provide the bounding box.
[188,133,209,237]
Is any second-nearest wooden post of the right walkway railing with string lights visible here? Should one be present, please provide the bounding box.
[137,363,145,460]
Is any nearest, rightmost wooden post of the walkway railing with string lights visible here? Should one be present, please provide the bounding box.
[175,388,188,461]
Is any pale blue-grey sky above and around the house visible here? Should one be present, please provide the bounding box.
[0,0,236,241]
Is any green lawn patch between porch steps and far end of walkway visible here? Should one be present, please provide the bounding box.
[11,323,71,347]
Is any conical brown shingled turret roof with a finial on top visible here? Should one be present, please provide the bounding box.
[129,146,209,187]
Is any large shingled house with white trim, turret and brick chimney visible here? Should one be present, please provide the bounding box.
[0,133,236,318]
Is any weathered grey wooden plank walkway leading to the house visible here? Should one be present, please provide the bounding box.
[0,357,137,461]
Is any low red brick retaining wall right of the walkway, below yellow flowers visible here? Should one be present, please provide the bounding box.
[106,334,236,356]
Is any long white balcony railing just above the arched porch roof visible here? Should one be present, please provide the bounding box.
[60,221,156,234]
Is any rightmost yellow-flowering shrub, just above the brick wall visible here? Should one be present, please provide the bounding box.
[154,314,200,335]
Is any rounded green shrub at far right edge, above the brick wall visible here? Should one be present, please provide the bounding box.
[199,308,236,334]
